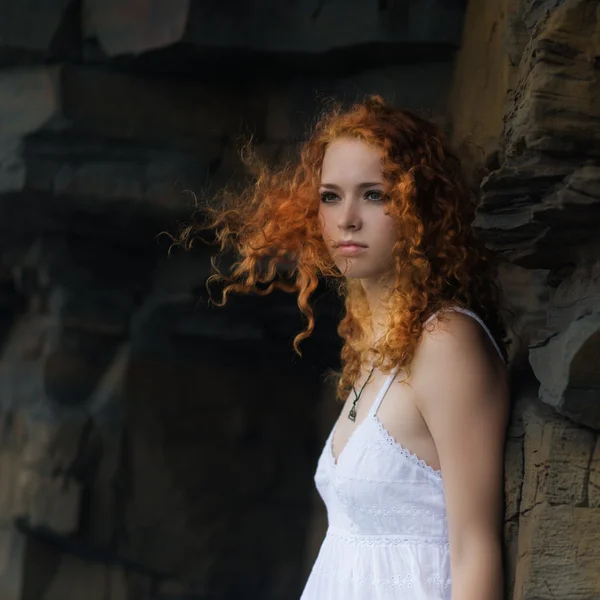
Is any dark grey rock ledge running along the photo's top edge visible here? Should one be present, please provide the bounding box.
[0,0,465,62]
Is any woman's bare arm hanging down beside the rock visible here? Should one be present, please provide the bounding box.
[411,313,510,600]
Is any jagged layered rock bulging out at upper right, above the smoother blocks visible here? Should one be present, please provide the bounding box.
[475,0,600,268]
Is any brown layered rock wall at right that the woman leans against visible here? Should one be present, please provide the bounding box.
[451,0,600,600]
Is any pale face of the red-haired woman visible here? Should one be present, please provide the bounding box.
[319,138,398,279]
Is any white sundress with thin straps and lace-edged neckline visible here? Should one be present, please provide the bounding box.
[300,307,502,600]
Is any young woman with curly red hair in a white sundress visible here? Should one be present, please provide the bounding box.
[180,97,509,600]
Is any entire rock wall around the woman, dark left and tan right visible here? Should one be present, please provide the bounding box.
[0,0,600,600]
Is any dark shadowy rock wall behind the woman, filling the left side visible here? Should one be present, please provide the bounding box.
[0,0,464,600]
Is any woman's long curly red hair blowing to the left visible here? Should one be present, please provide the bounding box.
[177,96,506,400]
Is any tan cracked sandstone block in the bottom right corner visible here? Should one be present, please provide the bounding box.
[505,394,600,600]
